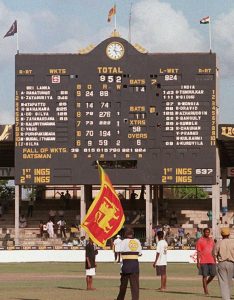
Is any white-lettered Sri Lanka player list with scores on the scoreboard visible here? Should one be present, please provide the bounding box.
[16,85,68,147]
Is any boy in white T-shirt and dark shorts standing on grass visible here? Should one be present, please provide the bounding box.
[153,231,168,291]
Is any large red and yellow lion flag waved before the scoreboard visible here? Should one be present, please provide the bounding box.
[81,164,125,247]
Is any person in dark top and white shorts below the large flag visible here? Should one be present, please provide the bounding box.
[85,238,98,291]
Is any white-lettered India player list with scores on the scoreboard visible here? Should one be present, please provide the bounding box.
[162,85,216,148]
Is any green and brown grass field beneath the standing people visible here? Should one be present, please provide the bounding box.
[0,263,229,300]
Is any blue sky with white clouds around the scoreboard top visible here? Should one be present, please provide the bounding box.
[0,0,234,124]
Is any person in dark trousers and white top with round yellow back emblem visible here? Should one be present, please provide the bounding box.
[117,228,142,300]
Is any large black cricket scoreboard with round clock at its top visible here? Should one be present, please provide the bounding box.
[15,37,216,184]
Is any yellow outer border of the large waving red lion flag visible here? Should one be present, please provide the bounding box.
[81,163,125,247]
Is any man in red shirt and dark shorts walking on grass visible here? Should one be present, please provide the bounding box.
[196,228,216,295]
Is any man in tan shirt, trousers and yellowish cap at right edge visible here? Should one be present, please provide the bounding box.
[214,227,234,300]
